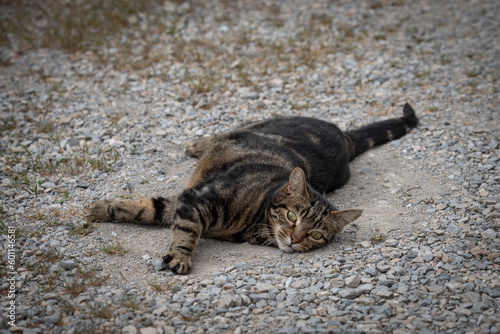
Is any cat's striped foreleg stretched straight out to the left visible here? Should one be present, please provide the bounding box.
[84,197,176,226]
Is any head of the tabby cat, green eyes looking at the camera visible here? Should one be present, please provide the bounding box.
[270,167,361,252]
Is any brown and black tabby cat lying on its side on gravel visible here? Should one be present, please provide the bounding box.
[85,104,418,274]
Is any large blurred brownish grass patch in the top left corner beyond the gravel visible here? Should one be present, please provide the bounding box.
[0,0,163,52]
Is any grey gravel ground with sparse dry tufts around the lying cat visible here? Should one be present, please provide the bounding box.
[0,0,500,334]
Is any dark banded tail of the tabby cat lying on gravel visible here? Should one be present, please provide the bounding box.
[345,103,418,160]
